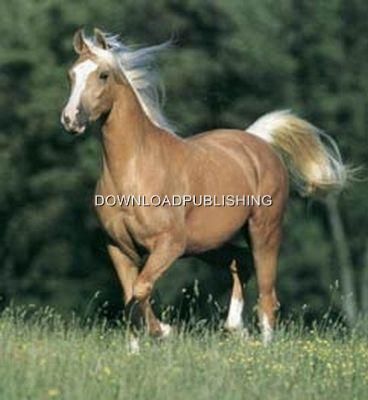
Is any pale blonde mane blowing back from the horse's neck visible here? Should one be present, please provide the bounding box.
[85,34,174,131]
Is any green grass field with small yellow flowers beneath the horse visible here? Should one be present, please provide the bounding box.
[0,310,368,400]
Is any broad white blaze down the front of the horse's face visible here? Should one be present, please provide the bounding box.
[64,60,97,121]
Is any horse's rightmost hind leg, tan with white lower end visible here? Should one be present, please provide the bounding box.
[249,220,281,344]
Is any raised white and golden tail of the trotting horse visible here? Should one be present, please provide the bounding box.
[246,111,348,196]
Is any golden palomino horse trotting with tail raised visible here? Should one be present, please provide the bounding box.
[61,30,346,342]
